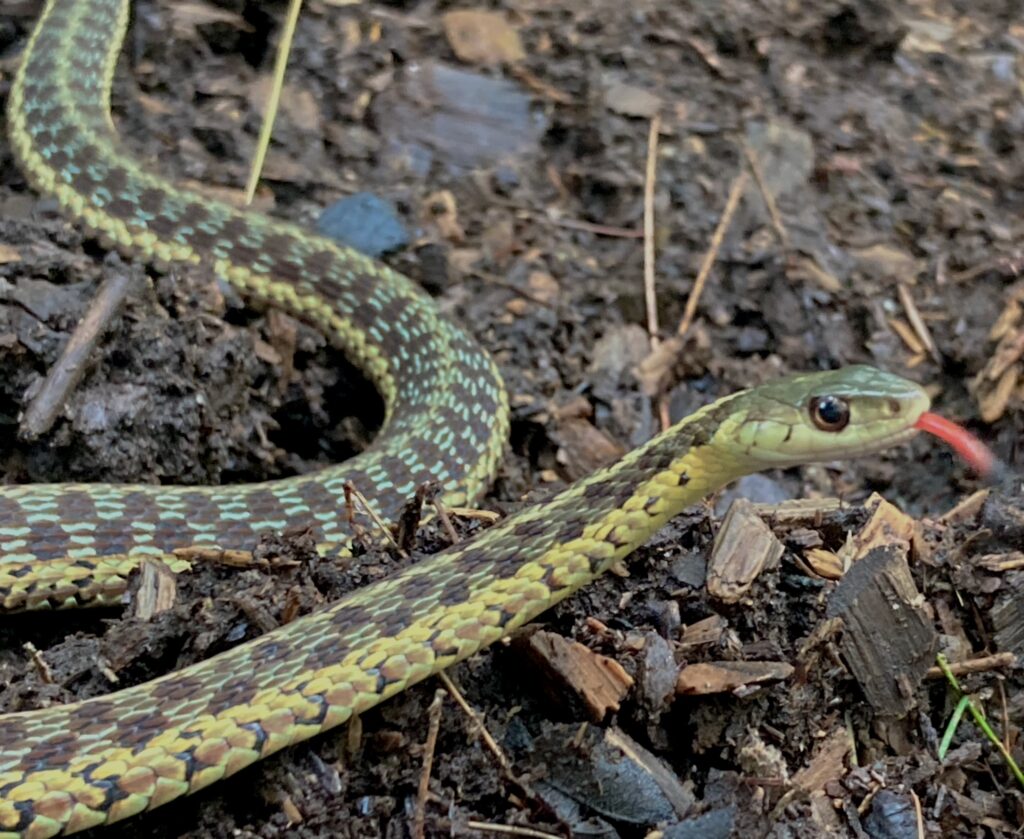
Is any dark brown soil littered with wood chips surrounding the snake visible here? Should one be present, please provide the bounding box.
[0,0,1024,839]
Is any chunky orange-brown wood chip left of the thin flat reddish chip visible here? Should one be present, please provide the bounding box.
[515,630,633,722]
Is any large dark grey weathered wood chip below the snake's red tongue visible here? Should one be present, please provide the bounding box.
[827,544,938,717]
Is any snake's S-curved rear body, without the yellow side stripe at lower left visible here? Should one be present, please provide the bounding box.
[0,0,508,573]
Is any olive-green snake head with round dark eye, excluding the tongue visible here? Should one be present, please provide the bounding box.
[722,365,931,468]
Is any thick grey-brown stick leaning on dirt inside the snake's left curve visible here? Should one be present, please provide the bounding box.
[18,270,132,442]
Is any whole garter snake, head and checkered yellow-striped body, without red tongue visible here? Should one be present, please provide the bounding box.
[0,0,929,837]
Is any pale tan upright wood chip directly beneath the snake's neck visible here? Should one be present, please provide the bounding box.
[708,498,783,603]
